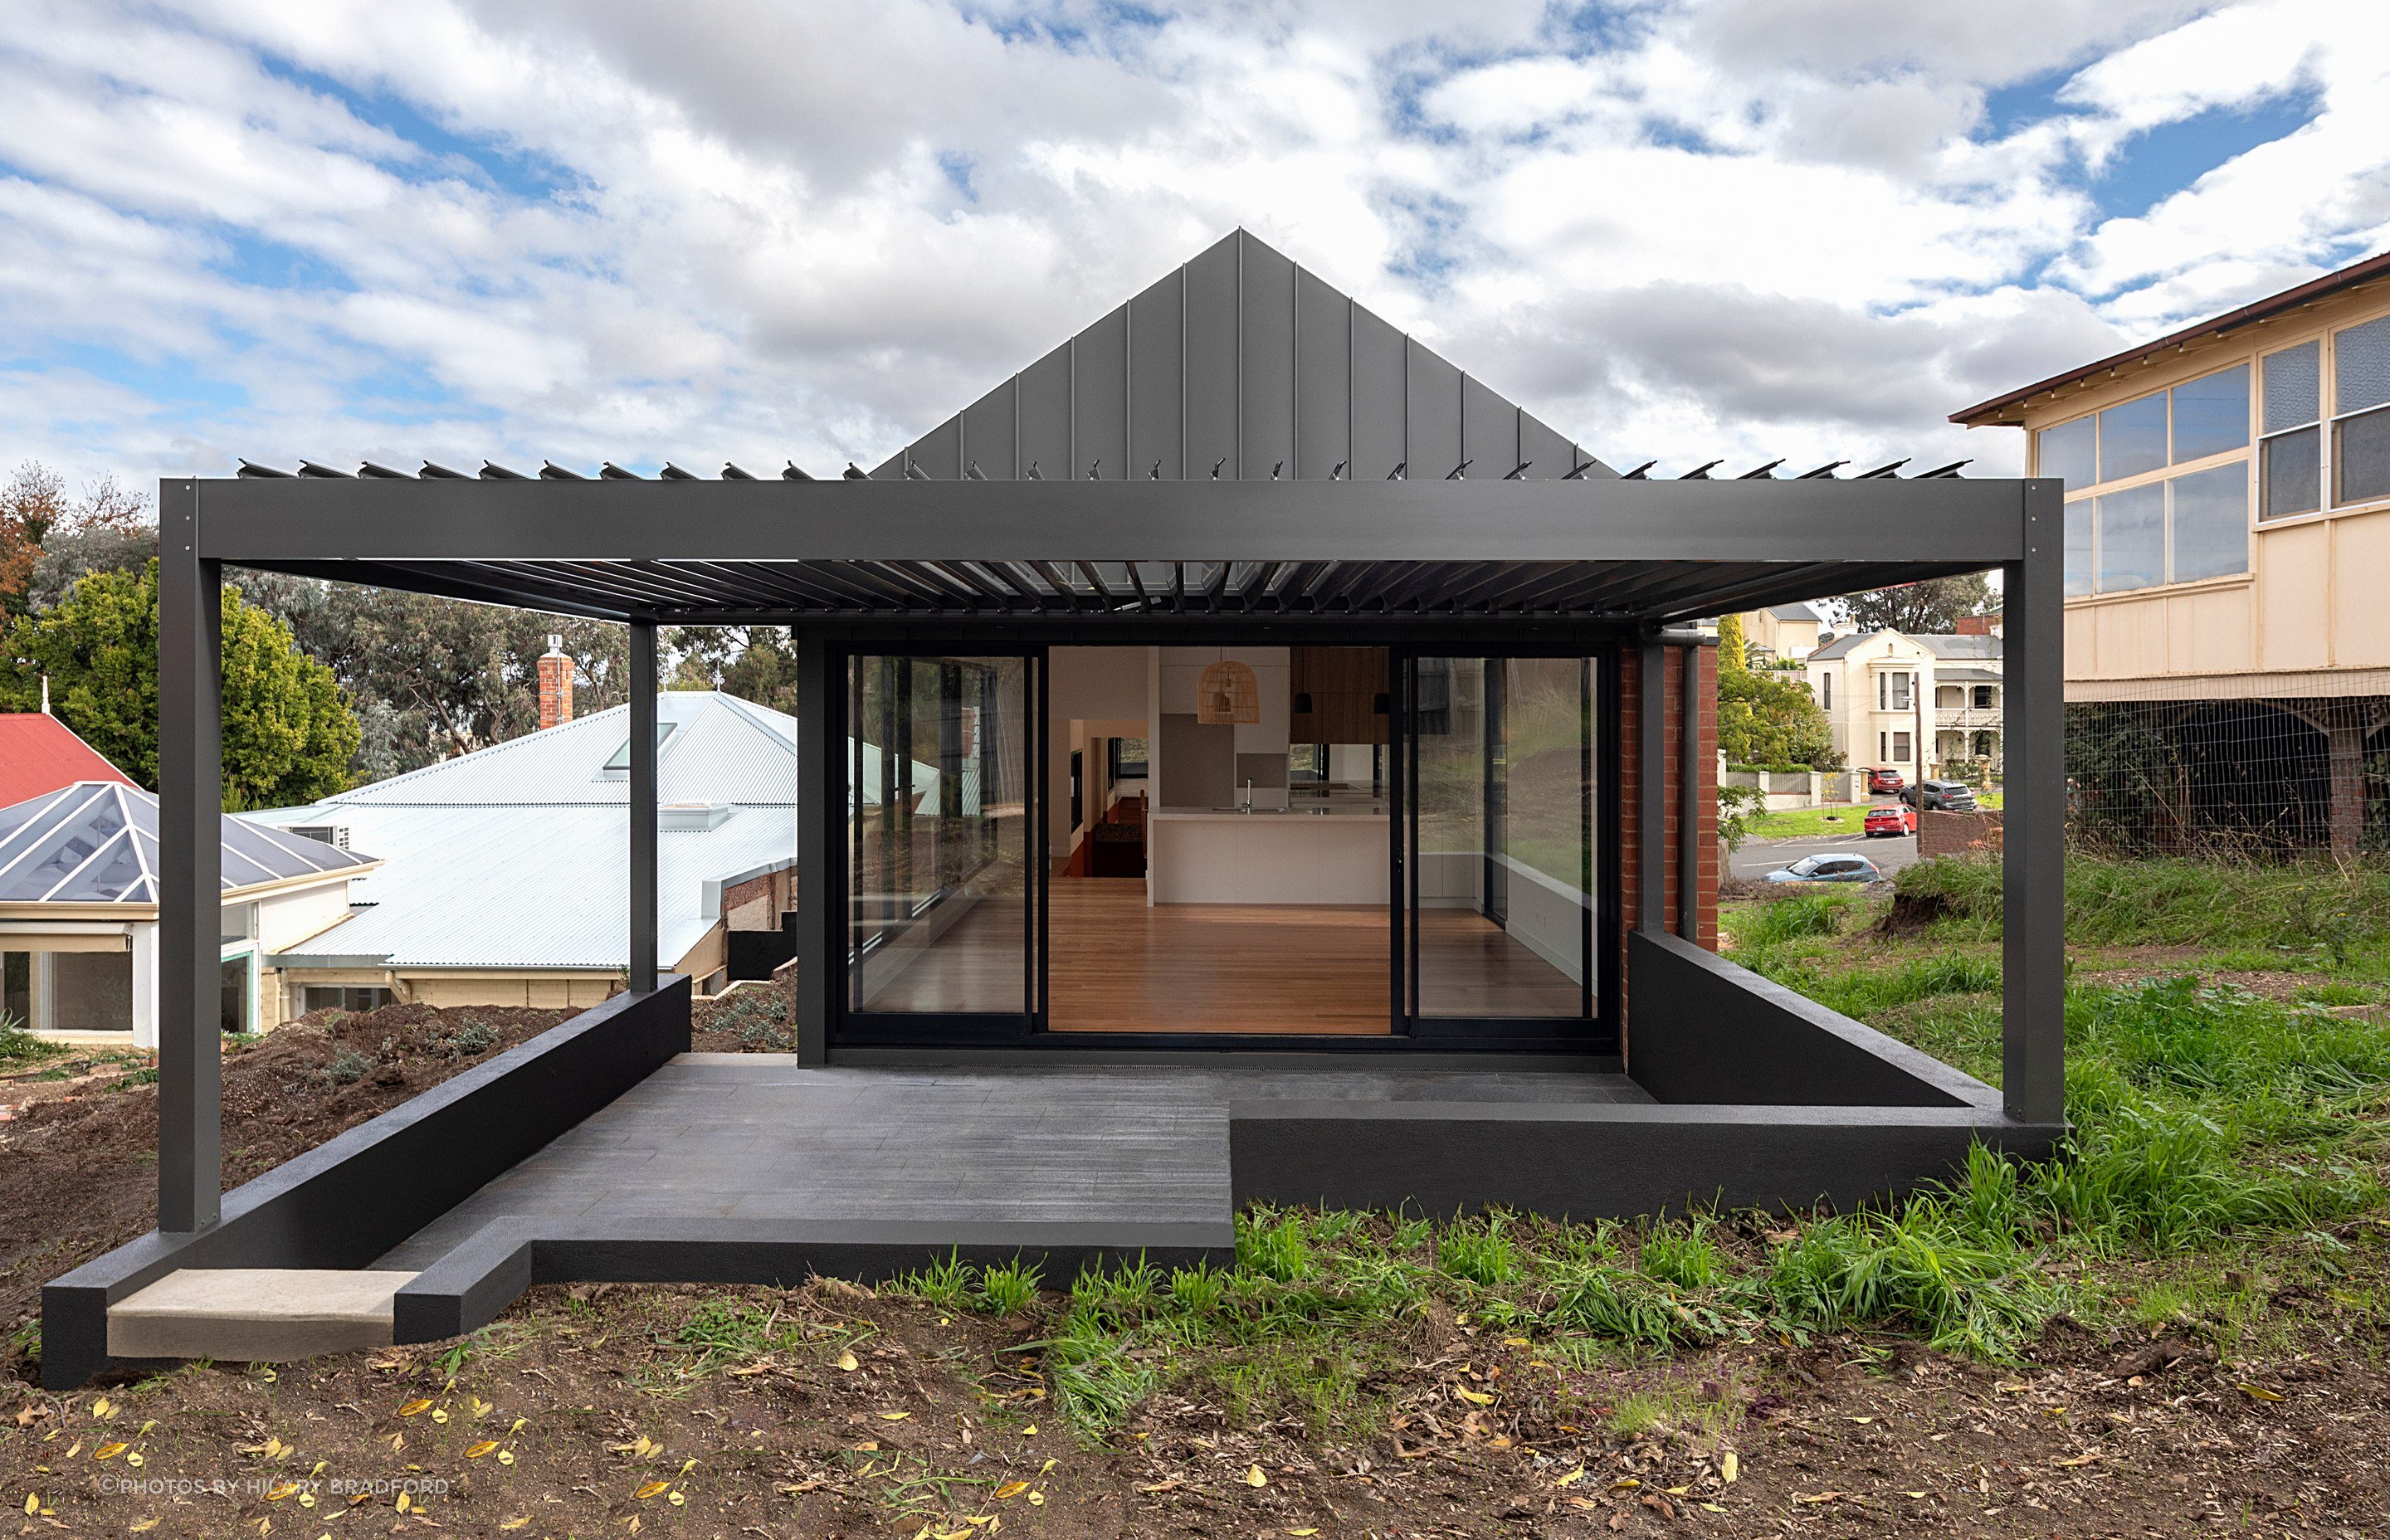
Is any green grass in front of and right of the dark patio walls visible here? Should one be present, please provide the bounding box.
[889,861,2390,1440]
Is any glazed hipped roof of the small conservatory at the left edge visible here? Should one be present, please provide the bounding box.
[0,782,373,904]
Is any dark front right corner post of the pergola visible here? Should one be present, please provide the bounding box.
[2001,480,2067,1124]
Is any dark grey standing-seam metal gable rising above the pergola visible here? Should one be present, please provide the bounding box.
[872,230,1616,480]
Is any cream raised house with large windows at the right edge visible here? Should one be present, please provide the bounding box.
[1950,253,2390,856]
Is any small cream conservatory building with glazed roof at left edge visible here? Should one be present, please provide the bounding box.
[0,784,380,1047]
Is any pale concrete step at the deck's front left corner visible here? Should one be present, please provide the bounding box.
[108,1267,416,1363]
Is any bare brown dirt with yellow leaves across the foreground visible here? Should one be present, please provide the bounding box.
[0,1282,2390,1540]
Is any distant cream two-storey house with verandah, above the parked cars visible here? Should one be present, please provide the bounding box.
[1807,621,2007,784]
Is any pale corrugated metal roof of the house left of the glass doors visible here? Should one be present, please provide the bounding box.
[249,691,860,968]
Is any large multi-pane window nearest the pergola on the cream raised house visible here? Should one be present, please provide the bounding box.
[2036,361,2246,597]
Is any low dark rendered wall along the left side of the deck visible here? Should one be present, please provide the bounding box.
[41,976,688,1389]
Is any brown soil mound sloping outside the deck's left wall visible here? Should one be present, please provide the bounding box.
[0,1004,571,1370]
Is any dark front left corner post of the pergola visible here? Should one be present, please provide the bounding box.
[158,480,225,1234]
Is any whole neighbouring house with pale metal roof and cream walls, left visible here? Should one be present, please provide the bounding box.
[244,675,796,1016]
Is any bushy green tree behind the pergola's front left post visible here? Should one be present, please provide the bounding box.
[0,562,358,813]
